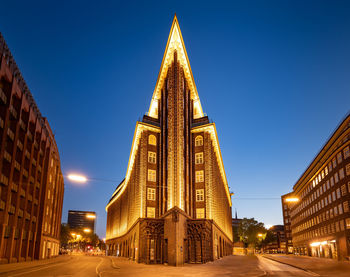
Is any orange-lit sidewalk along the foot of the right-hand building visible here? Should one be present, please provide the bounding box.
[262,254,350,276]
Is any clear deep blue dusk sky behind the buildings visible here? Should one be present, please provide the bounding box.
[0,1,350,237]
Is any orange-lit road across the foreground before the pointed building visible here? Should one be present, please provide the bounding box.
[0,253,319,277]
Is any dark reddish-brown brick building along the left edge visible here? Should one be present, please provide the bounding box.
[0,34,64,263]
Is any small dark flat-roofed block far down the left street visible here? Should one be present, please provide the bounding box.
[68,210,96,233]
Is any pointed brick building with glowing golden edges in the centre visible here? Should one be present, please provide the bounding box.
[106,16,232,265]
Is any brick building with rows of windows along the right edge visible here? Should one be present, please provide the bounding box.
[282,112,350,259]
